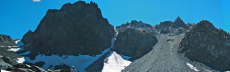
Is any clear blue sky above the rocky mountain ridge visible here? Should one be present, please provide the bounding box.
[0,0,230,39]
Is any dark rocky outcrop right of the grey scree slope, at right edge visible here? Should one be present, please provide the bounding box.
[179,20,230,71]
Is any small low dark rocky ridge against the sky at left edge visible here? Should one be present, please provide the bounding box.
[0,34,16,46]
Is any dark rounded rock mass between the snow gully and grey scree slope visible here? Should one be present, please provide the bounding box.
[112,21,157,60]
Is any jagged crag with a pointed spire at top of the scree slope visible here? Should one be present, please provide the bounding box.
[155,16,189,35]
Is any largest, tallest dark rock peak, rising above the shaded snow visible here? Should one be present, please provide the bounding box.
[22,1,114,55]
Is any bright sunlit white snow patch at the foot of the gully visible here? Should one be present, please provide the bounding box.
[102,52,132,72]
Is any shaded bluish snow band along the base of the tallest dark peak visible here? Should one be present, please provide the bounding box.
[22,38,116,72]
